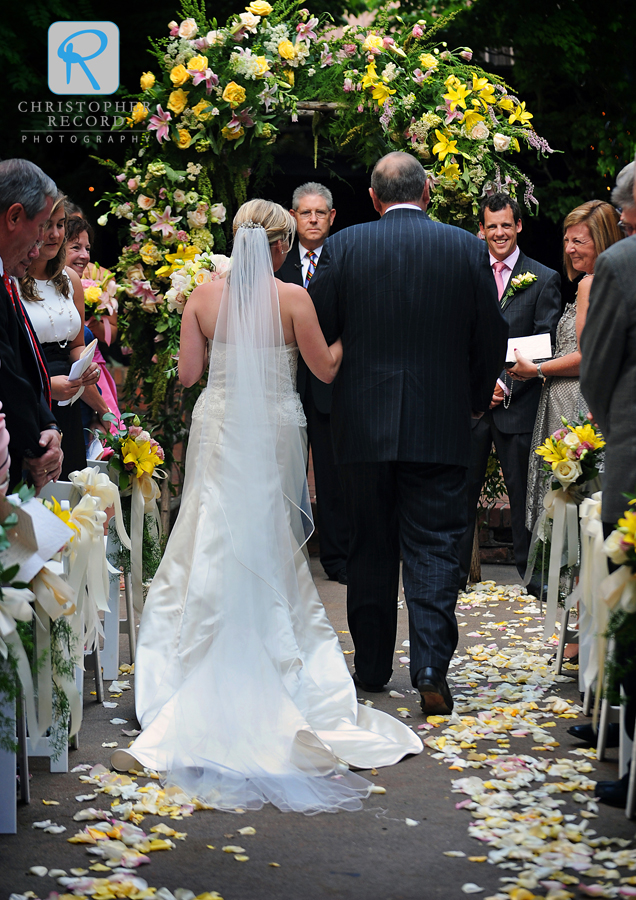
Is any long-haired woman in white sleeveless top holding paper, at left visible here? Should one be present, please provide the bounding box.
[19,195,99,479]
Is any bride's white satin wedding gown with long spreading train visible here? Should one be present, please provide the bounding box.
[113,239,422,814]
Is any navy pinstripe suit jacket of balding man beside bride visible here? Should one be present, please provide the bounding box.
[311,209,508,466]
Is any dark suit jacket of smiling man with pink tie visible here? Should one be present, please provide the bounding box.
[492,251,561,434]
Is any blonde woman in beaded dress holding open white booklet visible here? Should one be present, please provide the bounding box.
[510,200,623,531]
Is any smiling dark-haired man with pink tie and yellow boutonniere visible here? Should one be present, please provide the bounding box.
[459,193,561,590]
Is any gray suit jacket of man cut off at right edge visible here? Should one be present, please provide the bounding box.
[581,236,636,523]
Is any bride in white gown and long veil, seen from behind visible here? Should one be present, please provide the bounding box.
[112,200,422,814]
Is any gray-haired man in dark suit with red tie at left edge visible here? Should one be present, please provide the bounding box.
[0,159,62,491]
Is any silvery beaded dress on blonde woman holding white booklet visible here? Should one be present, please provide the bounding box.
[526,299,588,531]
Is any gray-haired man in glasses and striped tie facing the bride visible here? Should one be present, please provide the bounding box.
[276,181,349,584]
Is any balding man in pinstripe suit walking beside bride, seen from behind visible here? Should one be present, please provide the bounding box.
[310,153,508,714]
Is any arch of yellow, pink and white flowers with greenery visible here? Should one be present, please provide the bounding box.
[99,0,552,492]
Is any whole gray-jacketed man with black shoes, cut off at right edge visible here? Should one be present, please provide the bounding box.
[581,163,636,807]
